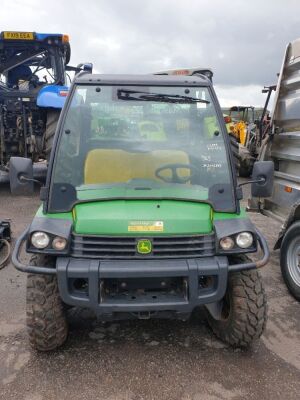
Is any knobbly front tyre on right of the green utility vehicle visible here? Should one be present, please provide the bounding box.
[207,260,267,347]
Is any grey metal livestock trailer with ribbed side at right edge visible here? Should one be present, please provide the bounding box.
[250,39,300,300]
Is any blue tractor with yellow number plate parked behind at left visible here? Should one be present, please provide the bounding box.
[0,31,82,171]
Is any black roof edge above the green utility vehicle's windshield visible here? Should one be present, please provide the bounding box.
[75,72,211,86]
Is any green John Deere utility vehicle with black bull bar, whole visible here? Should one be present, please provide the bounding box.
[11,73,272,350]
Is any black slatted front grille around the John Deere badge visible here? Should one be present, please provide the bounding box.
[71,234,215,260]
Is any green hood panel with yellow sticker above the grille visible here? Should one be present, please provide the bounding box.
[73,200,212,236]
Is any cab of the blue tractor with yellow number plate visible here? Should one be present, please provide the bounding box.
[0,32,71,91]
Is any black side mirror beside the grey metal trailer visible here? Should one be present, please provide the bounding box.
[251,161,274,197]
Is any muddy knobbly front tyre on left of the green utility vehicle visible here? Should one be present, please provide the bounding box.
[26,255,68,351]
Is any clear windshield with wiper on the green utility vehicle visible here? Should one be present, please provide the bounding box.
[50,85,234,209]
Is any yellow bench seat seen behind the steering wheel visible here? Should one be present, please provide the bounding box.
[84,149,189,184]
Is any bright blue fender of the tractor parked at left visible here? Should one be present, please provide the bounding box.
[37,85,69,108]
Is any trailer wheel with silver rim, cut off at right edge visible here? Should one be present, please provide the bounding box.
[280,222,300,301]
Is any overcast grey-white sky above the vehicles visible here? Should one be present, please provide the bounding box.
[0,0,300,106]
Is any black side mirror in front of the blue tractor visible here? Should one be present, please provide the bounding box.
[9,157,33,195]
